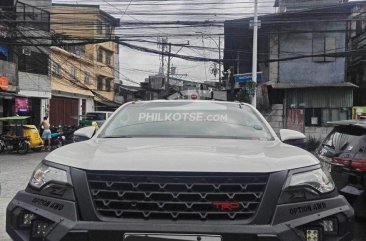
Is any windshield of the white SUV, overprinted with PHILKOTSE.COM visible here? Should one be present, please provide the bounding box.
[99,102,273,140]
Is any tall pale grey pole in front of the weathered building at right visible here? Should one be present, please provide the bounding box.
[252,0,258,108]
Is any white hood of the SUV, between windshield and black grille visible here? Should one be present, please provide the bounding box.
[46,138,319,173]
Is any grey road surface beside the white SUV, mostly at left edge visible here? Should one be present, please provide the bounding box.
[0,153,366,241]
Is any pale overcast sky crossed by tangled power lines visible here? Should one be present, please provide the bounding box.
[48,0,275,85]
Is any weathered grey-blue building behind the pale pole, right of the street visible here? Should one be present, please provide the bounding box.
[225,2,365,138]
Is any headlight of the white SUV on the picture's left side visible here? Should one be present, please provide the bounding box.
[29,163,69,189]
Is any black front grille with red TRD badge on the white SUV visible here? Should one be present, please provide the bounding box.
[87,172,268,221]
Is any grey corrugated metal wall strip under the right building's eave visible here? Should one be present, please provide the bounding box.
[286,88,353,108]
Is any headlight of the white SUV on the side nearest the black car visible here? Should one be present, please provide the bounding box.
[287,169,335,194]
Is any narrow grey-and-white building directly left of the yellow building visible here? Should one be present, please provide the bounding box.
[16,0,51,125]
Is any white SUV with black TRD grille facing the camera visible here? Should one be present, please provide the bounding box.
[6,100,354,241]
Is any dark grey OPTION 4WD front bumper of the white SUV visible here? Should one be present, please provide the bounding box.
[6,191,354,241]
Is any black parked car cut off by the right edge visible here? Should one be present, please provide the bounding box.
[316,120,366,217]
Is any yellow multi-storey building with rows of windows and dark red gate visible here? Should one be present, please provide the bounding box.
[50,4,119,125]
